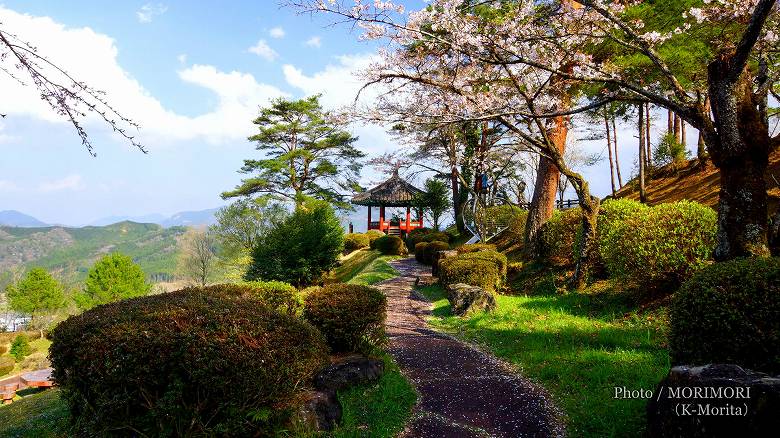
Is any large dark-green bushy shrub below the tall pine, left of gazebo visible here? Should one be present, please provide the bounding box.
[244,201,344,286]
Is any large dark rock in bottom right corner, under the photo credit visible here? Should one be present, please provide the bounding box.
[647,364,780,437]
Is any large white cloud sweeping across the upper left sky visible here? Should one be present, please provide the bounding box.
[0,6,285,145]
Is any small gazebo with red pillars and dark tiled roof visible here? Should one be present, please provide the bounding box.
[352,169,425,235]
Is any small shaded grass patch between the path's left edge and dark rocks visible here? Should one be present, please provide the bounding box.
[332,356,417,438]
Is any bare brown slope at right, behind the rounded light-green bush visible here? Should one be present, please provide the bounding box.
[615,151,780,212]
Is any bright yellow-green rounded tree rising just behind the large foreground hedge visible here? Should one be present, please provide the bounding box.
[76,253,152,309]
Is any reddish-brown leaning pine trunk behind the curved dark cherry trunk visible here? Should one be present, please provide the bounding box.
[525,117,569,258]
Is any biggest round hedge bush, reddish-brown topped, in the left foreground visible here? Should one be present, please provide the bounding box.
[50,289,328,436]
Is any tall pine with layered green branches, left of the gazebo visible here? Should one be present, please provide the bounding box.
[222,95,365,207]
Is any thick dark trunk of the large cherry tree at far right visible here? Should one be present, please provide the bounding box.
[705,57,770,261]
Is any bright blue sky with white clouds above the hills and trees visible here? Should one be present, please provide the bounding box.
[0,0,696,229]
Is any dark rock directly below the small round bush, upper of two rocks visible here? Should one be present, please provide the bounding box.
[314,356,385,391]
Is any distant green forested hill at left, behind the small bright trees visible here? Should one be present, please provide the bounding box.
[0,221,185,281]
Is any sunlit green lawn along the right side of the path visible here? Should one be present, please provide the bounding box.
[421,284,669,437]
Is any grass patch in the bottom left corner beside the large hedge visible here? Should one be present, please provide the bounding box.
[0,389,69,438]
